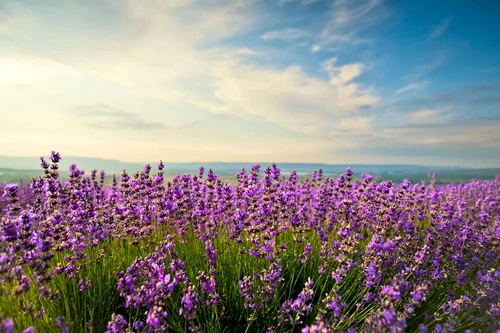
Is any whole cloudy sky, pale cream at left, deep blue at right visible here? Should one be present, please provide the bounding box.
[0,0,500,167]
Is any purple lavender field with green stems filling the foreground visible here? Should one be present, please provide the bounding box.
[0,152,500,333]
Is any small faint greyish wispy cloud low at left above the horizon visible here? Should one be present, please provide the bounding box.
[70,104,165,130]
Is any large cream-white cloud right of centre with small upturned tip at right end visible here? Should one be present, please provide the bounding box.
[213,58,378,135]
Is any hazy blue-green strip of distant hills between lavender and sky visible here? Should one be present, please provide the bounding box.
[0,156,500,183]
